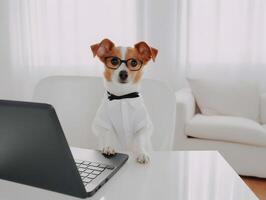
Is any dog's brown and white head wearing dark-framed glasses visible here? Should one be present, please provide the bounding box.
[91,39,158,86]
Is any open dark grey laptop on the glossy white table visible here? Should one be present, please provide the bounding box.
[0,100,128,198]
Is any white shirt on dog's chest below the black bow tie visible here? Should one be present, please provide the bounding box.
[94,94,152,148]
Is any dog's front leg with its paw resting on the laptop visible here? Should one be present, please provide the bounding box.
[92,124,117,155]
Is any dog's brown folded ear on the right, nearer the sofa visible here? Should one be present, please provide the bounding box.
[134,41,158,62]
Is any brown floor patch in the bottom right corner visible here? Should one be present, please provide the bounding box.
[241,176,266,200]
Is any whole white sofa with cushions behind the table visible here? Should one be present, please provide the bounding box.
[175,81,266,178]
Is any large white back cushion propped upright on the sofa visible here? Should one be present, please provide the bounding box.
[188,78,260,121]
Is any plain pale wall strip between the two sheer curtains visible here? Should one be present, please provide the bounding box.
[138,0,178,88]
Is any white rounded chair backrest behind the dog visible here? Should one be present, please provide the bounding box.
[33,76,176,150]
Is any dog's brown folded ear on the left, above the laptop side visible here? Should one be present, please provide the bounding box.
[91,39,115,58]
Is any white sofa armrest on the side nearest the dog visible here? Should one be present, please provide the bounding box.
[175,88,196,142]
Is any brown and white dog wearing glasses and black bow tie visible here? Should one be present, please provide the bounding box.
[91,39,158,164]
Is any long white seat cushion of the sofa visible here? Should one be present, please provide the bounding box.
[185,114,266,146]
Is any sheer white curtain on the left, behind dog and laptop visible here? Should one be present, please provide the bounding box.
[0,0,137,100]
